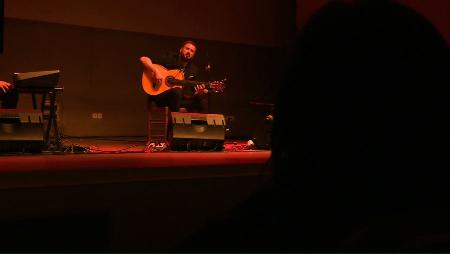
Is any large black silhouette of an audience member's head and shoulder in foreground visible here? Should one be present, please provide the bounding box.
[176,0,450,252]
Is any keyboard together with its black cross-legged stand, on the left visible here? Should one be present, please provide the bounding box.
[13,70,64,151]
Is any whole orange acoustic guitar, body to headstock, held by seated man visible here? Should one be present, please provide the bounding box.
[142,64,225,95]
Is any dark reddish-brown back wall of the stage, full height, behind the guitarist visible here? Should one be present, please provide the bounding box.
[0,0,296,137]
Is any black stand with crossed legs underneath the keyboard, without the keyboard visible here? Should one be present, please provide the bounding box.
[17,87,64,151]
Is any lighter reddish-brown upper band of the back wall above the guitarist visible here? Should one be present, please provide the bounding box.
[5,0,295,46]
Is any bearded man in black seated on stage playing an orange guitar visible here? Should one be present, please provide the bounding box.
[140,41,208,113]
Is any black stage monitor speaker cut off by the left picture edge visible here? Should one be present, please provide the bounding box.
[0,109,44,153]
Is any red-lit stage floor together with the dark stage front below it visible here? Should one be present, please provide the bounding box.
[0,138,270,250]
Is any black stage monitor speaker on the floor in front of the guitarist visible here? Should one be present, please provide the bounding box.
[171,112,226,151]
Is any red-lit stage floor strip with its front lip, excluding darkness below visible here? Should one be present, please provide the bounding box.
[0,137,270,189]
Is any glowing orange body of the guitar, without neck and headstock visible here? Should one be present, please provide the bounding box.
[142,64,184,95]
